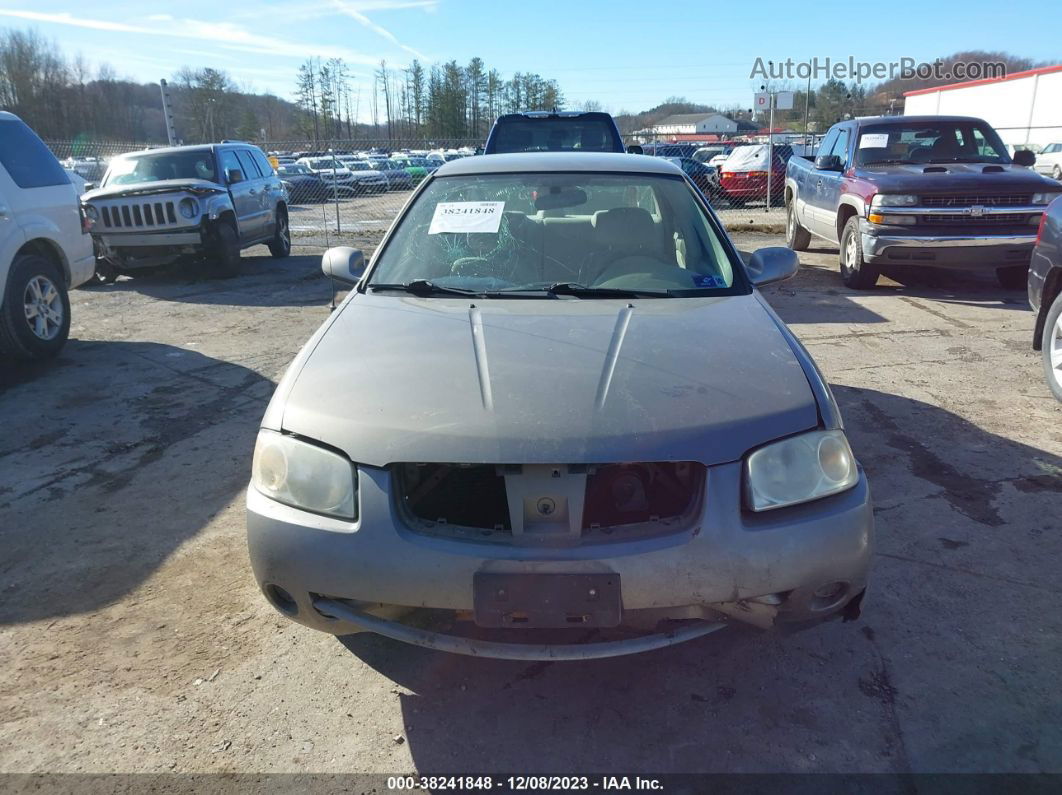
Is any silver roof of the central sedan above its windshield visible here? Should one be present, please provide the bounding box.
[435,152,682,176]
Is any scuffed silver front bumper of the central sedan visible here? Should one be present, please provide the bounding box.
[247,463,873,660]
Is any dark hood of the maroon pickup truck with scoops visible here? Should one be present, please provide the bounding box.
[856,162,1058,195]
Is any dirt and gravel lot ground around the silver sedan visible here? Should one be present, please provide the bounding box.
[0,231,1062,773]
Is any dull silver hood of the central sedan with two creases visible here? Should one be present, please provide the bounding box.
[278,294,819,466]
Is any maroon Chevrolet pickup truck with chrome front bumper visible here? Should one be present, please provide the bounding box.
[785,116,1062,290]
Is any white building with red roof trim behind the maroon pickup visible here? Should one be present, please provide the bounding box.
[904,64,1062,150]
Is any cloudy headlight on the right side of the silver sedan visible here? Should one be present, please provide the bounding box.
[744,431,859,511]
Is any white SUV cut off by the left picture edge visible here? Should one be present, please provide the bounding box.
[0,111,96,359]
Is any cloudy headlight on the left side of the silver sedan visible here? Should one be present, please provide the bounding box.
[251,430,358,519]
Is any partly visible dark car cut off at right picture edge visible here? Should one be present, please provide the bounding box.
[1029,197,1062,400]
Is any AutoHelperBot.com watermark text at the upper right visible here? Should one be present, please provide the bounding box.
[749,55,1007,83]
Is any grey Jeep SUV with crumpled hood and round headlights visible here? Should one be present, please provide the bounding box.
[82,142,291,281]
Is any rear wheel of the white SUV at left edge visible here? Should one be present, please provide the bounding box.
[0,254,70,359]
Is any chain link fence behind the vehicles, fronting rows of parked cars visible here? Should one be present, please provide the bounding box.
[48,136,789,246]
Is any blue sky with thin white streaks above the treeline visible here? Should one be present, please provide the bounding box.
[0,0,1062,116]
